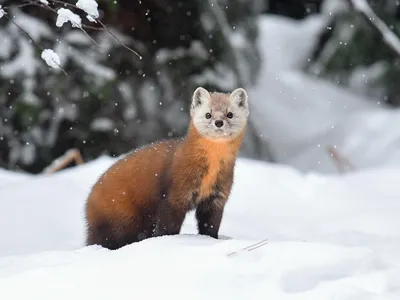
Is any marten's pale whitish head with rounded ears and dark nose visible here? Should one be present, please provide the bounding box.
[190,87,249,139]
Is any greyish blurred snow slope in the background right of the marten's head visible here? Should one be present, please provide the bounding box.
[249,0,400,173]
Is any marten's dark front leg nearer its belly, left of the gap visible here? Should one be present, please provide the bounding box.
[153,199,187,236]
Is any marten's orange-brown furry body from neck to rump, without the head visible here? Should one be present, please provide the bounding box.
[86,91,245,249]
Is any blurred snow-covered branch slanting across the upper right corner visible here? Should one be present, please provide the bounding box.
[348,0,400,56]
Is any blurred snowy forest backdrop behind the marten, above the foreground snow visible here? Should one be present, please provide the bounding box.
[0,0,400,173]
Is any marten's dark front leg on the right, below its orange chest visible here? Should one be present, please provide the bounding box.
[196,199,224,239]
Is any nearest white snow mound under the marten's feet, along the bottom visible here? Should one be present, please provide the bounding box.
[0,235,399,300]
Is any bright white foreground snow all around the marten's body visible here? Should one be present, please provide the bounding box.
[0,157,400,300]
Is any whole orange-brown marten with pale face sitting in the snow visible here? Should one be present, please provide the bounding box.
[85,87,249,250]
